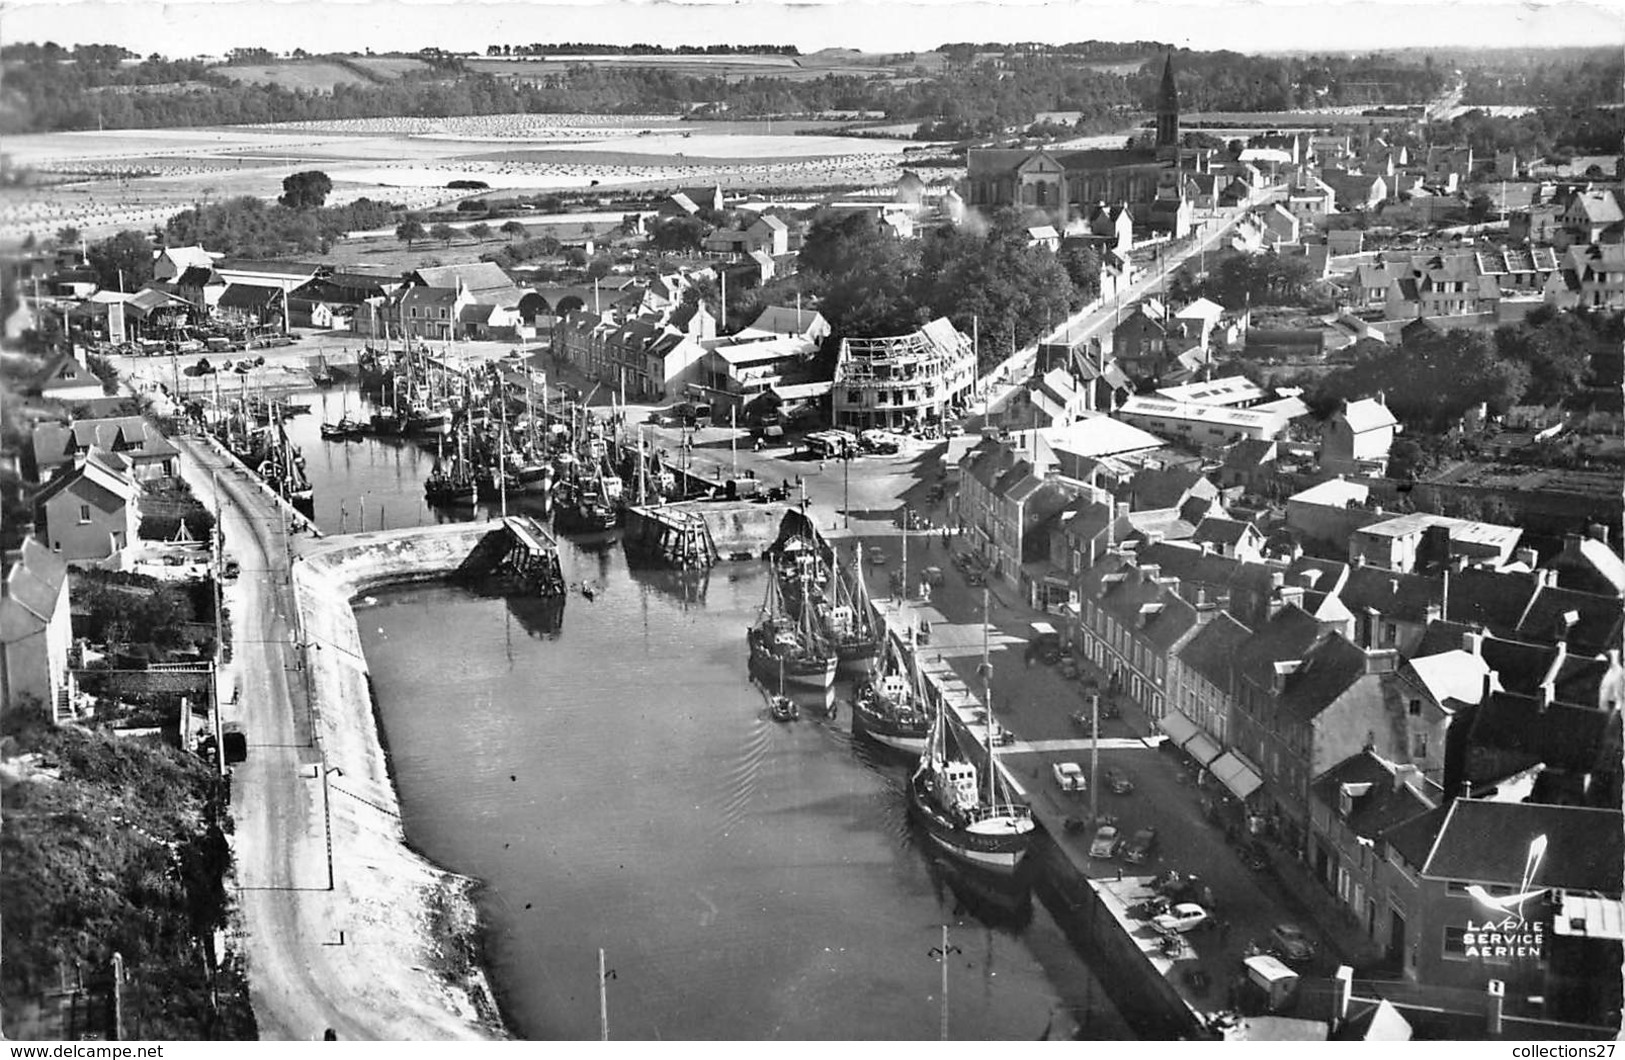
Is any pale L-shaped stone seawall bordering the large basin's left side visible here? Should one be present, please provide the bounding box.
[291,522,507,1037]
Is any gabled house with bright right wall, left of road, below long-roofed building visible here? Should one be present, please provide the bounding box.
[34,449,141,569]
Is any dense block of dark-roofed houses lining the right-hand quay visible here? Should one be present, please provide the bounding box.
[1068,543,1625,993]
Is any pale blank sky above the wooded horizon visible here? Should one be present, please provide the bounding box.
[0,0,1625,57]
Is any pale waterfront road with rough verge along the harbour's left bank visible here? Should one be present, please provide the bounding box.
[174,437,487,1040]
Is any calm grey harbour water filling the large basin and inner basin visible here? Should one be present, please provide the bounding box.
[293,392,1128,1040]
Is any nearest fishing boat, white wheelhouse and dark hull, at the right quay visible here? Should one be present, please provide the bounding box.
[908,593,1034,873]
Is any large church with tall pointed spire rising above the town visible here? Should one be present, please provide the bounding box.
[964,54,1206,239]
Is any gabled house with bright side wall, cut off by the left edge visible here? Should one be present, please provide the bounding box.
[0,538,73,717]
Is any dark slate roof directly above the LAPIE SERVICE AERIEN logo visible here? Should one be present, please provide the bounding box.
[1422,798,1625,896]
